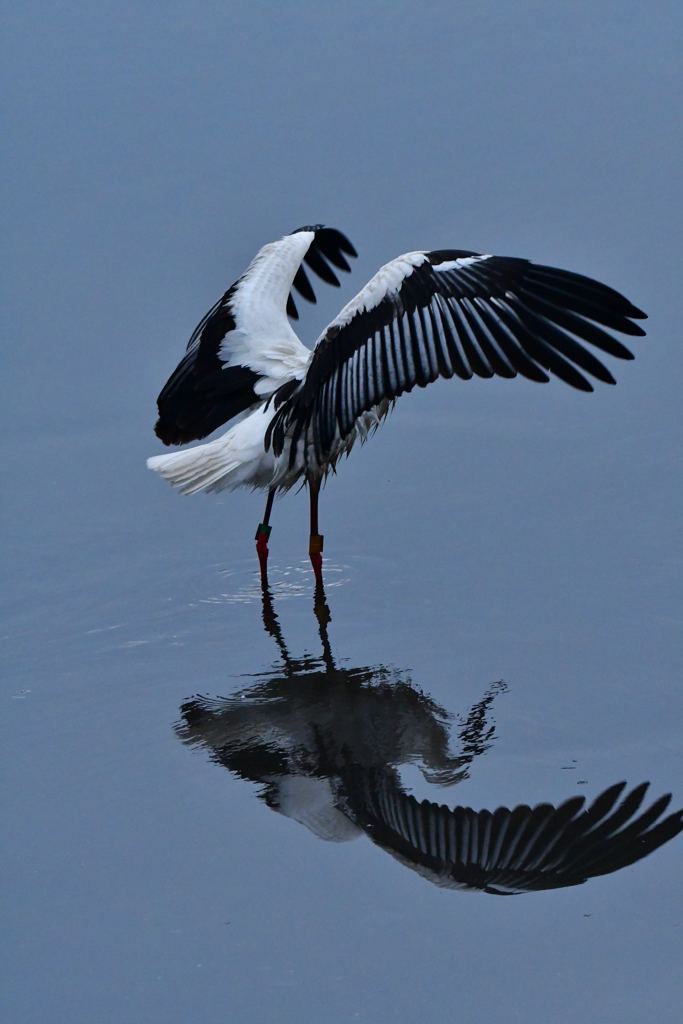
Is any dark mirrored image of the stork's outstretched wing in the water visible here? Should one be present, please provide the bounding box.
[350,775,683,895]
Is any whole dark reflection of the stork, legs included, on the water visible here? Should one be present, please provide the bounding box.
[176,585,683,895]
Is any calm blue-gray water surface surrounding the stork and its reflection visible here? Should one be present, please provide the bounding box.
[0,0,683,1024]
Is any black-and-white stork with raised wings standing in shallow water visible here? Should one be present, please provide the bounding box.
[147,224,646,582]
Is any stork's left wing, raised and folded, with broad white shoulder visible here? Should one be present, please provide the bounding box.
[156,224,356,444]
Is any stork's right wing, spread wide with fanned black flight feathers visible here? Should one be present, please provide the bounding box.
[267,249,645,461]
